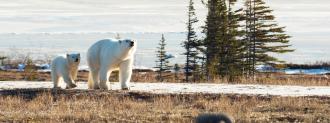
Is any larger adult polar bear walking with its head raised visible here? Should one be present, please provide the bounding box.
[87,39,136,90]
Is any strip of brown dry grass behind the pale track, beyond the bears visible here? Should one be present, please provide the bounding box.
[0,71,330,86]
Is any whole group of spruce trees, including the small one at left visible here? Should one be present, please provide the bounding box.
[157,0,294,82]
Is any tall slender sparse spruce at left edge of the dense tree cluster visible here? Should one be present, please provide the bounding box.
[183,0,200,82]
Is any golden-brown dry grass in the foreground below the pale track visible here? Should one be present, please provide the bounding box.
[0,89,330,123]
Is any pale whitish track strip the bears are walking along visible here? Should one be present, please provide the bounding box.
[0,81,330,97]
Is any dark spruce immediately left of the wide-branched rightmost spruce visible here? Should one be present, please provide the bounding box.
[223,0,246,82]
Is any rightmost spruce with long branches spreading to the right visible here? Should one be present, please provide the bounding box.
[245,0,294,76]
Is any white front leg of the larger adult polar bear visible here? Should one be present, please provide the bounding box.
[119,59,133,90]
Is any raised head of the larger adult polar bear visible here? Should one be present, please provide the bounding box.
[118,39,137,56]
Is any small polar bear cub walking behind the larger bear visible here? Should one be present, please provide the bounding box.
[51,53,80,89]
